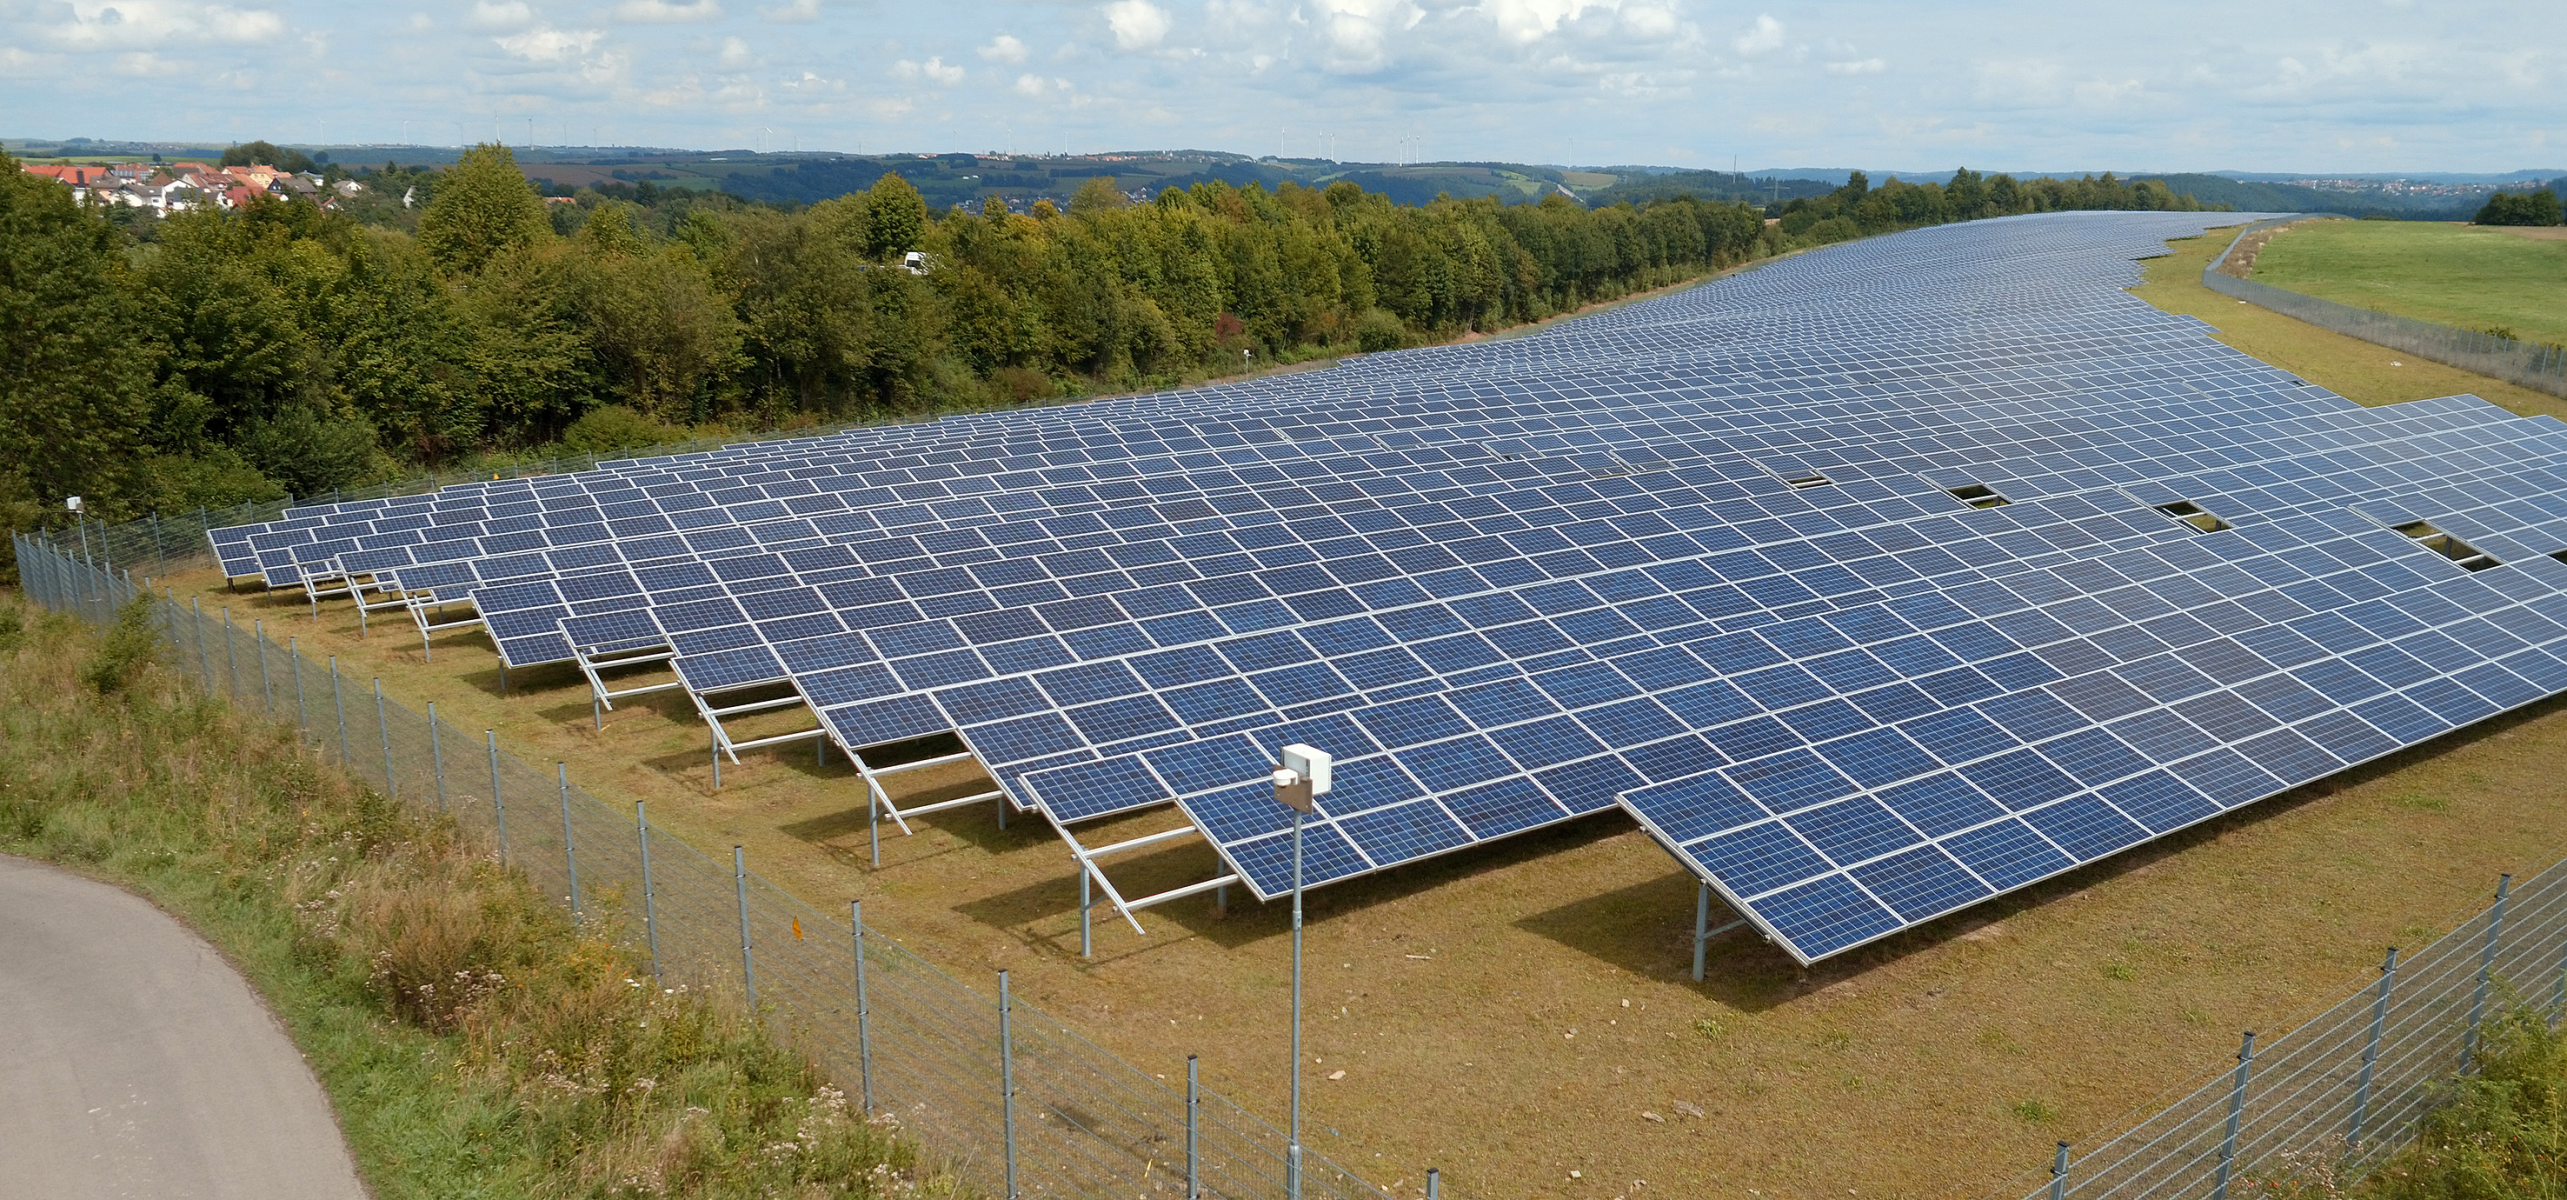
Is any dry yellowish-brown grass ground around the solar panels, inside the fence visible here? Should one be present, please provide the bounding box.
[140,231,2567,1200]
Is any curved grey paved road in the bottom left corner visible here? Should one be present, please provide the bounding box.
[0,856,365,1200]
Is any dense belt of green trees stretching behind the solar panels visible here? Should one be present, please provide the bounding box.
[0,146,2190,549]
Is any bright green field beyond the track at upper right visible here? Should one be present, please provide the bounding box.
[2254,221,2567,342]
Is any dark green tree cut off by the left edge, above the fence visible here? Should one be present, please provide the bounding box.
[0,154,154,524]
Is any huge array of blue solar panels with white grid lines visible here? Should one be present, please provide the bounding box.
[213,213,2567,961]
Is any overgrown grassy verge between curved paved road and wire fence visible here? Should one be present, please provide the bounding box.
[0,611,955,1200]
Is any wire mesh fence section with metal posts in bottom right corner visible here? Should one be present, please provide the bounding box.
[2005,863,2567,1200]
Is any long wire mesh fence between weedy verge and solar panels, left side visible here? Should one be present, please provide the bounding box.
[13,527,1389,1200]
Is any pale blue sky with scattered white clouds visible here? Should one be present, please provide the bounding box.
[0,0,2567,172]
